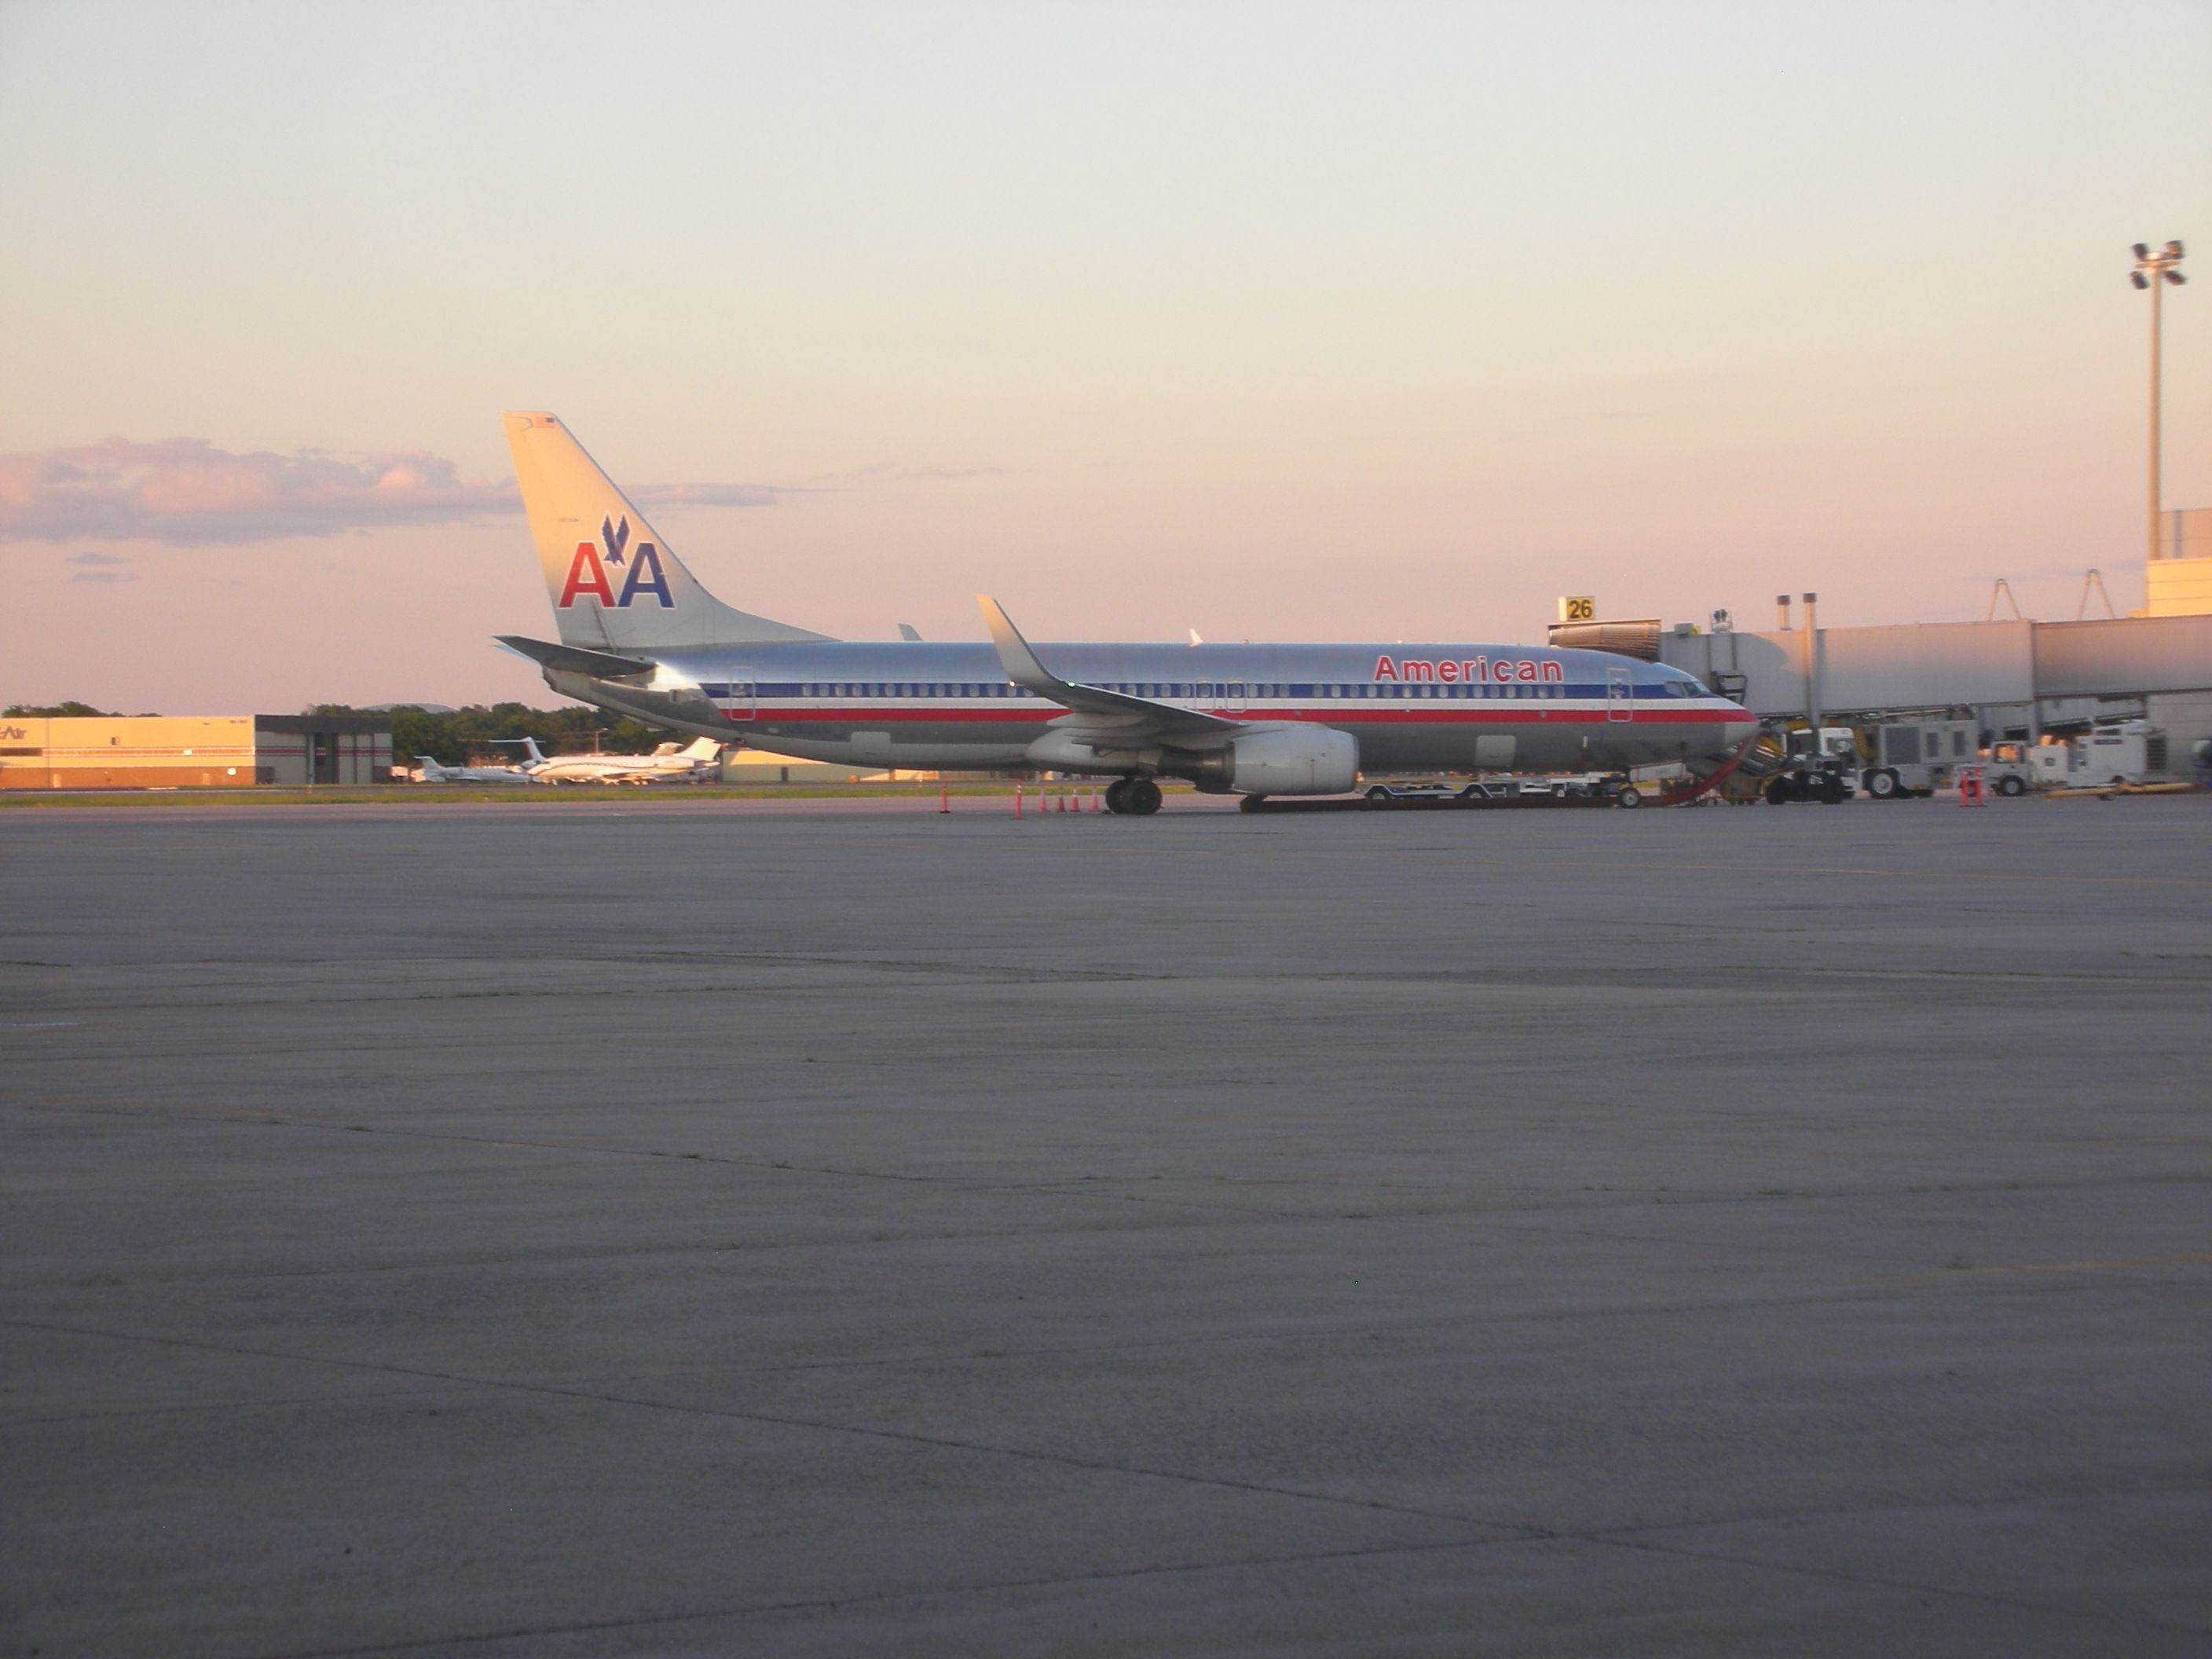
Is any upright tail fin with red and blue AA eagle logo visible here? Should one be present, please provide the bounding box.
[502,412,825,650]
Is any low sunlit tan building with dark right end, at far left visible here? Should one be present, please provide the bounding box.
[0,715,391,789]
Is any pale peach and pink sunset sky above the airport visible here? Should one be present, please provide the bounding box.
[0,0,2212,712]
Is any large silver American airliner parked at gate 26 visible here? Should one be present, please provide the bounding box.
[498,412,1759,816]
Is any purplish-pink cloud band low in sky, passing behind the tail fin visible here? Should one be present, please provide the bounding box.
[0,438,778,548]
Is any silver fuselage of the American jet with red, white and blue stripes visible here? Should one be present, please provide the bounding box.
[547,642,1754,775]
